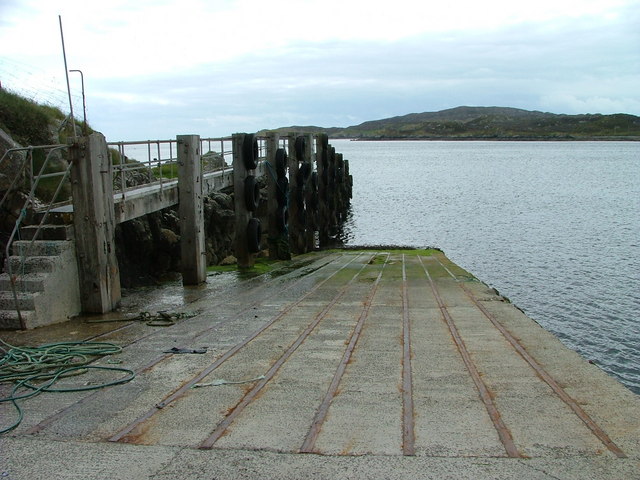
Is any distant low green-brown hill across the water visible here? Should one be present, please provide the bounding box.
[260,107,640,140]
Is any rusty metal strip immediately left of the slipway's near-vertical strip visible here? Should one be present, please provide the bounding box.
[300,254,389,453]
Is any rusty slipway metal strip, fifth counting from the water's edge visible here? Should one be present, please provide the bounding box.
[199,255,372,449]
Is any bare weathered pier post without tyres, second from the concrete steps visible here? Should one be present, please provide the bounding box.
[177,135,207,285]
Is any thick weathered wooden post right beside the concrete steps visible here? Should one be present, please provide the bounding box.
[70,133,121,313]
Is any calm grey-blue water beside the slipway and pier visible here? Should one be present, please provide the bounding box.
[332,140,640,394]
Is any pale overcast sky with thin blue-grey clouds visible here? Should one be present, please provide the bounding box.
[0,0,640,141]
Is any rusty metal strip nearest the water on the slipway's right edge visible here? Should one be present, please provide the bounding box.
[437,255,627,458]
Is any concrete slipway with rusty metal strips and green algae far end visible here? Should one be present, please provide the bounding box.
[0,251,640,480]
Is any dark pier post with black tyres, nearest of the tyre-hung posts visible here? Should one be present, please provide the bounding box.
[232,133,262,268]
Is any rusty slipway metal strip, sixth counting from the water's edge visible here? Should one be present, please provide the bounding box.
[109,255,359,442]
